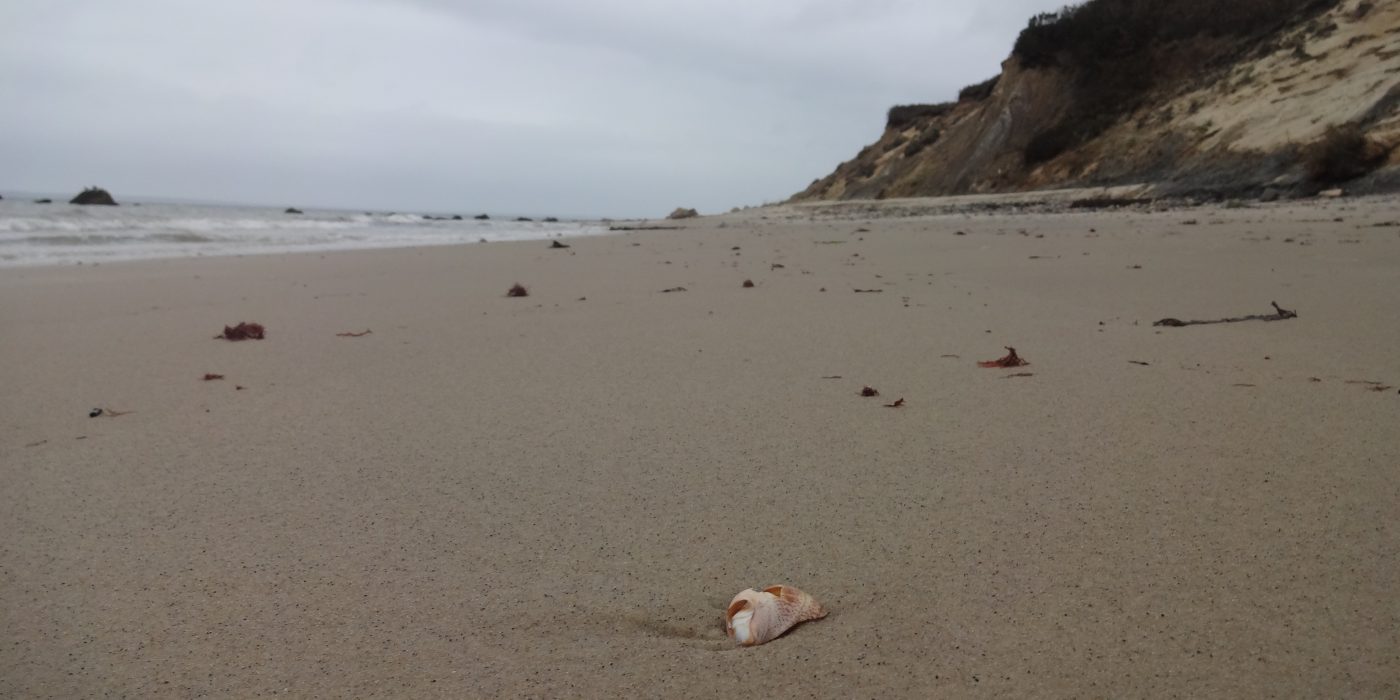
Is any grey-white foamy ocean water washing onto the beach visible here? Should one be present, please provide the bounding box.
[0,193,608,267]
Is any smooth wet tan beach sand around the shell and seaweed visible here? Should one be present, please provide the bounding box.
[0,197,1400,697]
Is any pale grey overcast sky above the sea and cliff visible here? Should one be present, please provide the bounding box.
[0,0,1064,217]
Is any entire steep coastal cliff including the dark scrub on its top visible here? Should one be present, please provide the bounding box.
[792,0,1400,200]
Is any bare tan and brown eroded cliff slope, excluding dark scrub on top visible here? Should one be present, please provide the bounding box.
[792,0,1400,200]
